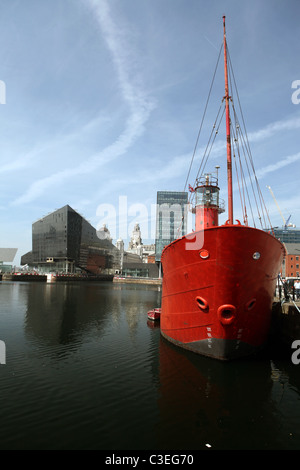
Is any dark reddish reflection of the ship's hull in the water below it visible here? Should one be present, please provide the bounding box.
[157,338,300,450]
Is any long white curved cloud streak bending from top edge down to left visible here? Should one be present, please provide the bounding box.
[12,0,155,205]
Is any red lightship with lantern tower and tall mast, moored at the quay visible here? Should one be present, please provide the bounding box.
[160,17,285,360]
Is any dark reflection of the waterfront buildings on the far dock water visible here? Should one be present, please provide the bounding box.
[25,283,160,344]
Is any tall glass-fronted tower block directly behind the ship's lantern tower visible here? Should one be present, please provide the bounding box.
[155,191,188,262]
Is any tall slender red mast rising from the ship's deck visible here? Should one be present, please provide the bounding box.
[223,16,233,224]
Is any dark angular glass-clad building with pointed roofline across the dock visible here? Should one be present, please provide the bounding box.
[21,205,120,274]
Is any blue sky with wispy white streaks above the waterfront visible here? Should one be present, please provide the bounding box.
[0,0,300,264]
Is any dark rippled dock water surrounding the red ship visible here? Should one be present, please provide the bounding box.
[0,281,300,450]
